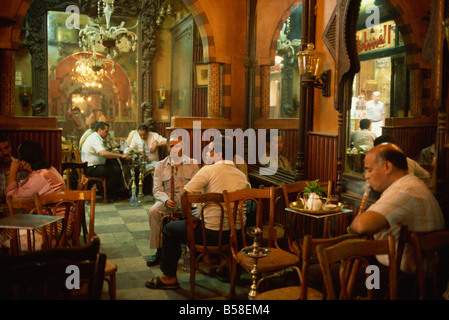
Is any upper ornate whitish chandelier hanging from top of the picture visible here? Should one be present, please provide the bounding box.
[79,0,137,59]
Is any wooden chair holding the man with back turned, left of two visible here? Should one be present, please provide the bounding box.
[181,192,229,299]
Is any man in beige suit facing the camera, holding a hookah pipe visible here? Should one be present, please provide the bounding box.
[147,136,199,267]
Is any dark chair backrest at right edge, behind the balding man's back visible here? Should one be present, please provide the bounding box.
[410,230,449,300]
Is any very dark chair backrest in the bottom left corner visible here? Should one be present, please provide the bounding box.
[0,237,106,300]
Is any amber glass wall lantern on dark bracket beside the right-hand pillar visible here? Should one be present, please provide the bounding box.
[296,43,331,97]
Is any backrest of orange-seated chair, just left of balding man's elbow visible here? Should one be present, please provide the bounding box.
[299,233,360,300]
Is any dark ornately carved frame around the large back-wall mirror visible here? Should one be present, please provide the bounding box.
[25,0,165,124]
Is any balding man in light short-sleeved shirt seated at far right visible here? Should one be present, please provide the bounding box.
[348,143,445,297]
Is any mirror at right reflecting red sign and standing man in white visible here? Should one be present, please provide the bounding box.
[345,0,436,177]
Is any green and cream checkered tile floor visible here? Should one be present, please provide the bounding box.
[87,196,250,300]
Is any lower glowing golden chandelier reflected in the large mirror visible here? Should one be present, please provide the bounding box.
[72,52,115,88]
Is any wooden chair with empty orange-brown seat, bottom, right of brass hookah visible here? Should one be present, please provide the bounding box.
[256,234,359,300]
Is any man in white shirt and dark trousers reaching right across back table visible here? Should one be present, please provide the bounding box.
[81,122,131,202]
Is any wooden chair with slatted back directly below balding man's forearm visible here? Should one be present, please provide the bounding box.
[317,236,397,300]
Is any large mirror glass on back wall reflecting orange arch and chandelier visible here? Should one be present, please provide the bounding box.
[47,11,138,141]
